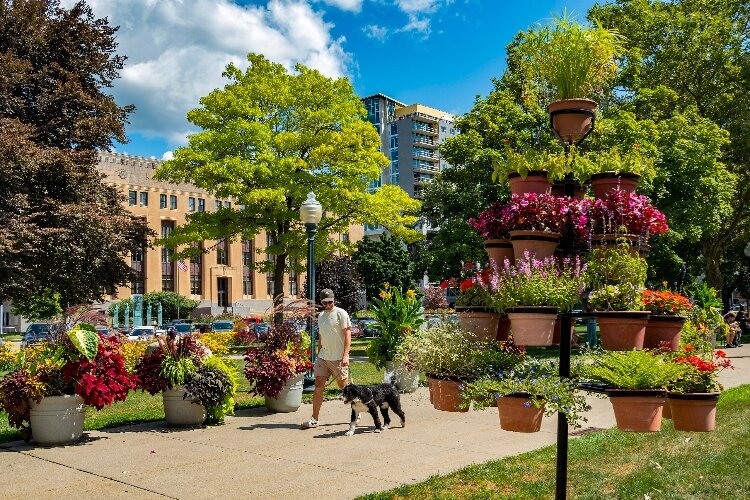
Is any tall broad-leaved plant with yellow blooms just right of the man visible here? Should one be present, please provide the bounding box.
[367,283,425,368]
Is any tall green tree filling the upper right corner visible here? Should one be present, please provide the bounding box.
[589,0,750,300]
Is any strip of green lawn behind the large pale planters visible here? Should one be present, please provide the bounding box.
[0,360,383,443]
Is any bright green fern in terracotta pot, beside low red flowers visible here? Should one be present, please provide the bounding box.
[573,350,685,390]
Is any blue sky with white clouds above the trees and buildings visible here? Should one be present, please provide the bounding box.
[70,0,595,158]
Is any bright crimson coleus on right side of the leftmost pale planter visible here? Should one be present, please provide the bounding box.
[63,338,136,410]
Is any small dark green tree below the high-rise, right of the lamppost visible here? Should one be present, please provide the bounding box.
[352,234,414,300]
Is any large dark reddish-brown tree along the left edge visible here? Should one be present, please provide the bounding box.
[0,0,150,309]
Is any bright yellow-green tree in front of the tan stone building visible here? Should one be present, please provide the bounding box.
[156,54,419,304]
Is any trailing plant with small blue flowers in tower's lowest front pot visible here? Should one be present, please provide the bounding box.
[461,358,591,428]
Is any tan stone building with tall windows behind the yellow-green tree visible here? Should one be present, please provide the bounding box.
[98,153,364,315]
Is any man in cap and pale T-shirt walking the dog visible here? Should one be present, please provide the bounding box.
[302,288,352,429]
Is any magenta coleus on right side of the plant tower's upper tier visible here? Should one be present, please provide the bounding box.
[582,188,669,241]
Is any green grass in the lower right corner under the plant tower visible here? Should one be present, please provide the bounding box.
[361,385,750,500]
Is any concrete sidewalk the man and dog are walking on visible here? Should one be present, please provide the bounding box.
[0,346,750,499]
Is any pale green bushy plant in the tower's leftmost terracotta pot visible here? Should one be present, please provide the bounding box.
[395,322,524,380]
